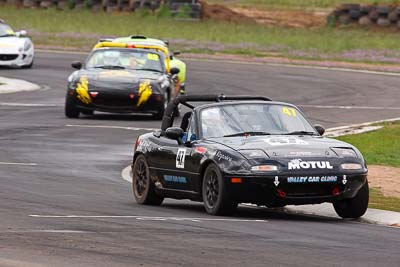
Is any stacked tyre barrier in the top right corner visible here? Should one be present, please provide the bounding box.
[327,4,400,28]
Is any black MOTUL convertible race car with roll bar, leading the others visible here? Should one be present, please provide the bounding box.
[132,95,369,218]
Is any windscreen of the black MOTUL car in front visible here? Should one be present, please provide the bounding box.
[200,103,317,138]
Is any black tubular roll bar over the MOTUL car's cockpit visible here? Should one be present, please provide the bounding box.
[161,94,271,131]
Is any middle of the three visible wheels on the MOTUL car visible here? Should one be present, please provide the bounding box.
[202,163,238,215]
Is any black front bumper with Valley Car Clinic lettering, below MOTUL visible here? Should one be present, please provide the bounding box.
[224,173,367,207]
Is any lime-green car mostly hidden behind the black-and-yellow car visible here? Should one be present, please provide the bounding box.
[111,35,186,84]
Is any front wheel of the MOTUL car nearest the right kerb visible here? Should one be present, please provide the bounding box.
[333,181,369,219]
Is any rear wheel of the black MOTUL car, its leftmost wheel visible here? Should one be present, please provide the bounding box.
[132,155,164,205]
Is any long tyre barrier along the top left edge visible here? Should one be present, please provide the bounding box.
[0,0,202,19]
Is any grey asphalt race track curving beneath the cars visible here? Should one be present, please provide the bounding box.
[0,53,400,266]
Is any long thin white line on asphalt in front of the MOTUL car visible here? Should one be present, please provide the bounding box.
[29,214,268,222]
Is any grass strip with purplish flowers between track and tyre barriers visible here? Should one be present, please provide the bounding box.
[0,6,400,64]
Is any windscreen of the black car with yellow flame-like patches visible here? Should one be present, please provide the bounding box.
[86,49,163,72]
